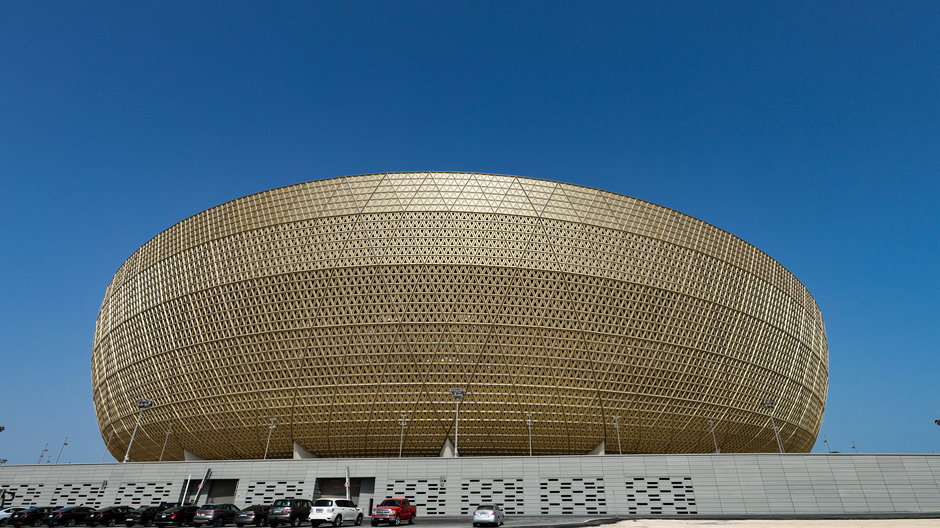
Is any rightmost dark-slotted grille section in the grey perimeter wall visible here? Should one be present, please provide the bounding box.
[626,477,697,515]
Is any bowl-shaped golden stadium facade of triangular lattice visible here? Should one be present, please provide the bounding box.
[92,173,828,460]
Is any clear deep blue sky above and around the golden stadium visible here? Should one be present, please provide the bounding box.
[0,1,940,463]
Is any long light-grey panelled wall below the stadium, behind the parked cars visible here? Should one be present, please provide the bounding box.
[0,454,940,518]
